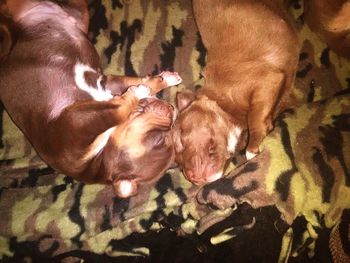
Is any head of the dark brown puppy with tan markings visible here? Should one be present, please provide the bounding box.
[104,98,174,198]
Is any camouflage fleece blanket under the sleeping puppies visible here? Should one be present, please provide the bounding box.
[0,0,350,262]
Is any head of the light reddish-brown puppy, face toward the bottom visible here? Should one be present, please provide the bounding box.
[172,92,240,185]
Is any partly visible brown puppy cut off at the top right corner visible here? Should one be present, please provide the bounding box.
[304,0,350,59]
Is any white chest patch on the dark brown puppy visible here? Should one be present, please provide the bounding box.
[74,63,113,101]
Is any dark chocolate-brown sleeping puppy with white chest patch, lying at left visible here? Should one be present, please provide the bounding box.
[0,0,181,197]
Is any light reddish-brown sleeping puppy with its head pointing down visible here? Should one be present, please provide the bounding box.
[173,0,299,184]
